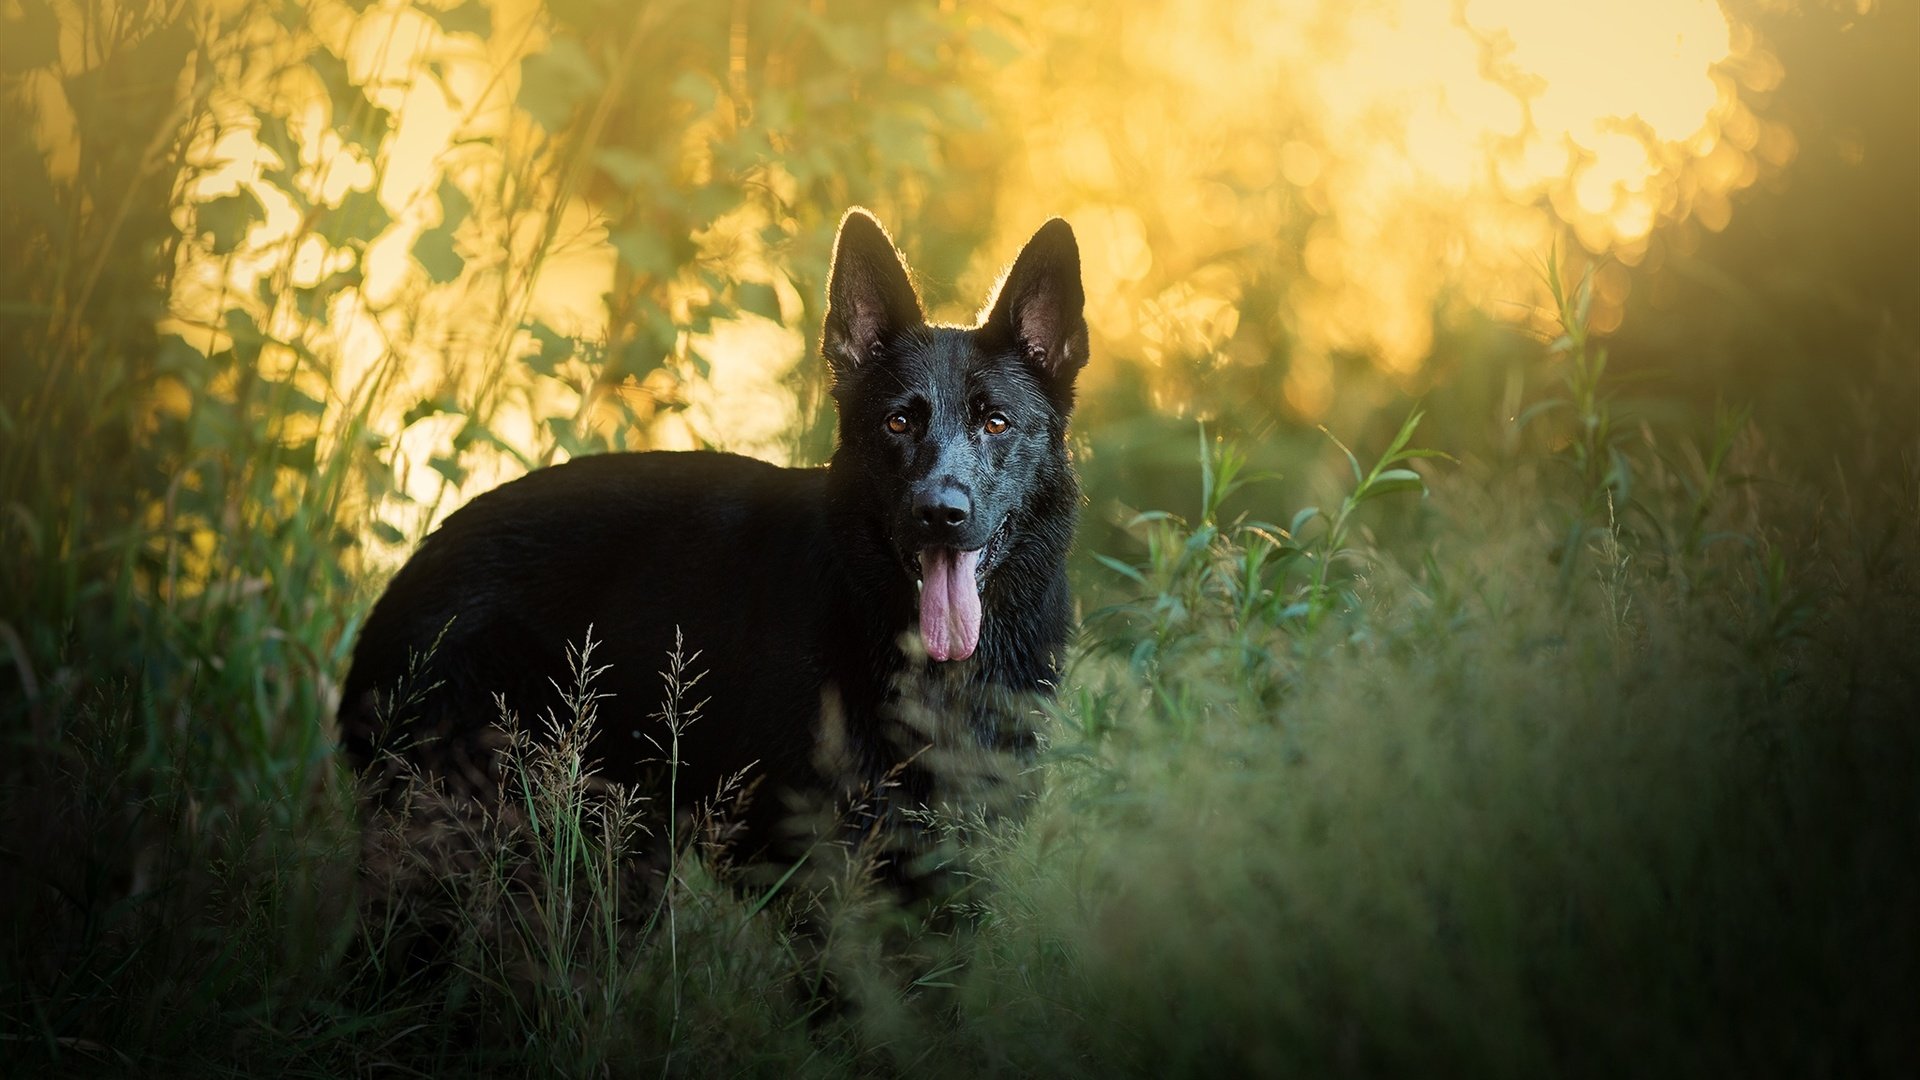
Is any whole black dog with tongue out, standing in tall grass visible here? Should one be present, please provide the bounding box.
[340,209,1087,883]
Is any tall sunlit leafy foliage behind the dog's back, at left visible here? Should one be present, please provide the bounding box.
[0,2,985,791]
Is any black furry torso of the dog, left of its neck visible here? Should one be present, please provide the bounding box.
[342,454,825,782]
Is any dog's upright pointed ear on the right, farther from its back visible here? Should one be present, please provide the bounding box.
[981,217,1087,390]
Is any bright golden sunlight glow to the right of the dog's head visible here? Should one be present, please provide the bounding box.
[981,0,1791,399]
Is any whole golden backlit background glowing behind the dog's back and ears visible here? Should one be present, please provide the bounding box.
[0,0,1874,553]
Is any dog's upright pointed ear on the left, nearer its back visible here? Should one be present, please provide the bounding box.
[820,206,922,379]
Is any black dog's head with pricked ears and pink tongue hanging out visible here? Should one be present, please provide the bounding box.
[820,209,1087,659]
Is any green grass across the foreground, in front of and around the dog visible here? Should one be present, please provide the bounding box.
[4,342,1920,1076]
